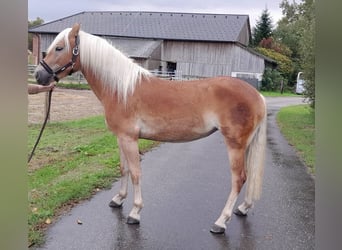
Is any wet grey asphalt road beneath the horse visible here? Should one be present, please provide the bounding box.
[34,97,315,250]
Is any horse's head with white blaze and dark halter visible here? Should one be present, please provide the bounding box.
[34,24,80,85]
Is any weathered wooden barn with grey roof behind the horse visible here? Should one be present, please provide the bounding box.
[29,11,276,87]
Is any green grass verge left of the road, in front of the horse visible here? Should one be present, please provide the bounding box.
[28,116,154,245]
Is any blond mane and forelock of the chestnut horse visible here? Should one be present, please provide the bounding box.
[49,28,151,102]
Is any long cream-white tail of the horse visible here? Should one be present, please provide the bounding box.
[246,97,267,202]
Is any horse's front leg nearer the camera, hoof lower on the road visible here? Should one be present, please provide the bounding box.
[118,136,143,224]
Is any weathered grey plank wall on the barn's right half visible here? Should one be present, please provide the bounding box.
[162,41,265,77]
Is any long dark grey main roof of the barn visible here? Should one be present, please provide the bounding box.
[29,11,250,42]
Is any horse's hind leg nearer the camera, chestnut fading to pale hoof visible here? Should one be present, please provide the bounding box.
[210,146,246,233]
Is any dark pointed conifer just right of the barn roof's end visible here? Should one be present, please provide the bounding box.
[252,8,273,46]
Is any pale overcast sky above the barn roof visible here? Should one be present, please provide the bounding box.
[28,0,282,27]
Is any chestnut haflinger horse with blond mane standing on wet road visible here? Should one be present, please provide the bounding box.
[35,24,267,233]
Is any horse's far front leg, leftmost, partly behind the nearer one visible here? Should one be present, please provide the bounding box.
[109,144,129,208]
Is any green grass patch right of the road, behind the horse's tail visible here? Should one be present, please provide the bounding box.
[277,105,315,174]
